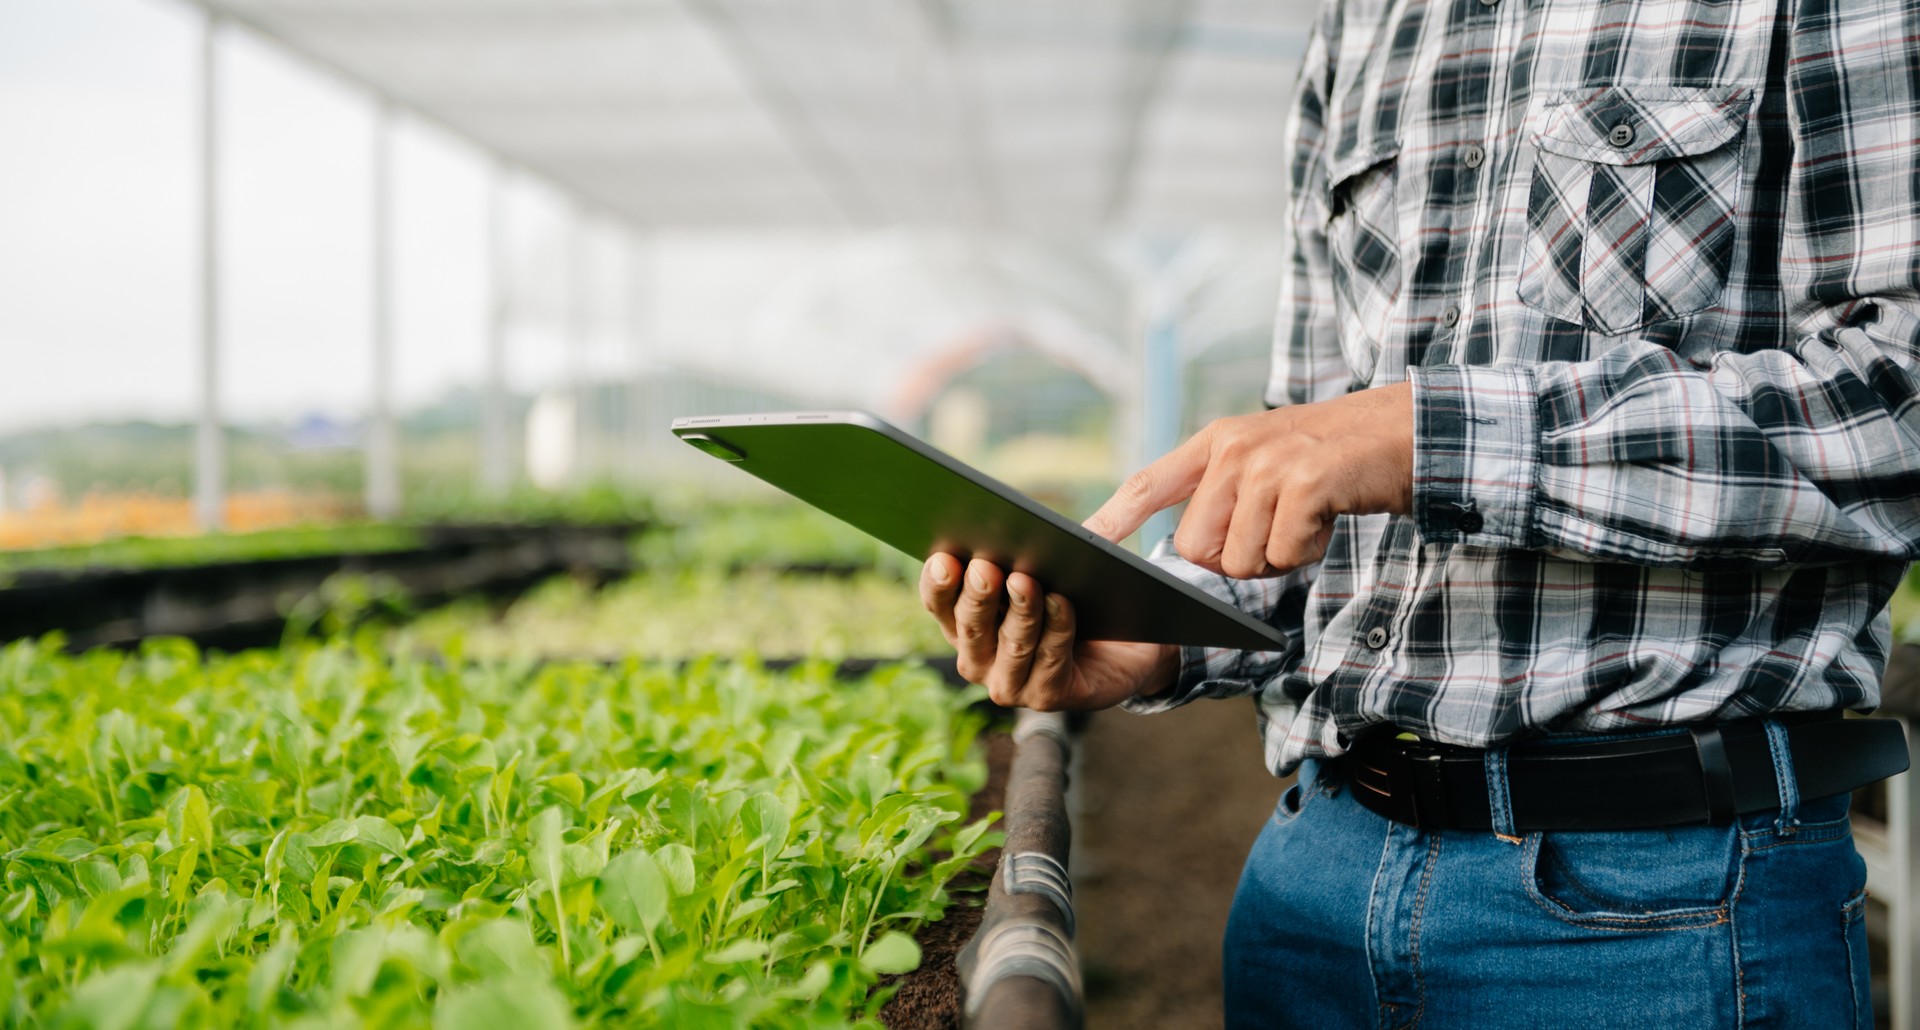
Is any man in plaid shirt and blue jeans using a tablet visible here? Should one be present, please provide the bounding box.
[922,0,1920,1026]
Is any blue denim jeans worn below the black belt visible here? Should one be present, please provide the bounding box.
[1225,736,1872,1030]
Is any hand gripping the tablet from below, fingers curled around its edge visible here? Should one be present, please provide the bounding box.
[920,553,1181,711]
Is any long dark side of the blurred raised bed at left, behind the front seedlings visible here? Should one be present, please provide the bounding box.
[0,523,634,650]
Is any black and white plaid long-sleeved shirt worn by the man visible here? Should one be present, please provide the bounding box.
[1129,0,1920,773]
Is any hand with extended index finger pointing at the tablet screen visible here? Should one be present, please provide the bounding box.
[1087,382,1413,578]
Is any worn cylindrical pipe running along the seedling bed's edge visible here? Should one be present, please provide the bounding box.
[960,711,1085,1030]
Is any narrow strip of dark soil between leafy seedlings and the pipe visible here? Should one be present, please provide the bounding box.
[879,732,1014,1030]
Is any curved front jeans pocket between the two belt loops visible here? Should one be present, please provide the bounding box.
[1523,826,1741,930]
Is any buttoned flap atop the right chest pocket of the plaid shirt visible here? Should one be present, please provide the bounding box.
[1534,86,1753,165]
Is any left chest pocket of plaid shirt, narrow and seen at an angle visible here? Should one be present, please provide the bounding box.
[1327,148,1402,382]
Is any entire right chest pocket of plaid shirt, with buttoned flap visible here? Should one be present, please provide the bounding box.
[1517,86,1751,336]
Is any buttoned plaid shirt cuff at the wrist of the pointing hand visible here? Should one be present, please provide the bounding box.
[1409,365,1540,548]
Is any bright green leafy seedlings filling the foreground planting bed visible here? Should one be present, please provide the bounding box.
[0,640,998,1028]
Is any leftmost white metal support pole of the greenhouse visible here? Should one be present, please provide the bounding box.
[194,12,227,530]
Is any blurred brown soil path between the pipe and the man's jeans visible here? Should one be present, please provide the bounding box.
[1073,699,1284,1030]
